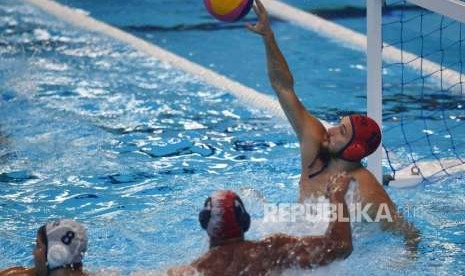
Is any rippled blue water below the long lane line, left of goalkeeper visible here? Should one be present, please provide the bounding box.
[0,1,298,271]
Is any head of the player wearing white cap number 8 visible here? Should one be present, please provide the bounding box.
[33,219,87,275]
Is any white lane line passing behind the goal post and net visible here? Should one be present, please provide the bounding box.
[262,0,465,94]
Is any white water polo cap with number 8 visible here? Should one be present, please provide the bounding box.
[45,219,87,269]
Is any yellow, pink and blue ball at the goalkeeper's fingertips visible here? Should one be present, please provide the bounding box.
[203,0,253,22]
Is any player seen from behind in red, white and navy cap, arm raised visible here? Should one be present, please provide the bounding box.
[168,174,352,276]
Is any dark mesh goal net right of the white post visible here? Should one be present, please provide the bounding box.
[368,0,465,186]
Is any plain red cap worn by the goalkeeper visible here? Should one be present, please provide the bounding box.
[339,115,381,162]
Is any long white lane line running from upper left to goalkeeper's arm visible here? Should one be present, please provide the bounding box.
[24,0,329,129]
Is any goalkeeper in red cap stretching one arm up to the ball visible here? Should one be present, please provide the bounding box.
[247,0,419,250]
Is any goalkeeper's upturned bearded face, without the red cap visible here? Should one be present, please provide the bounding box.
[323,117,352,154]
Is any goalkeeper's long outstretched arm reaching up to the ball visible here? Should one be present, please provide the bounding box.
[247,0,326,147]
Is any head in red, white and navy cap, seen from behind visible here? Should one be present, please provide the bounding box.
[199,191,250,246]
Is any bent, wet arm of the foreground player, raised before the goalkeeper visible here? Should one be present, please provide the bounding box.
[267,174,352,268]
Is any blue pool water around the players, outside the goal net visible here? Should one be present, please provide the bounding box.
[0,0,465,275]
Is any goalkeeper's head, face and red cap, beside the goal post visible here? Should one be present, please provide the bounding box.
[326,115,381,162]
